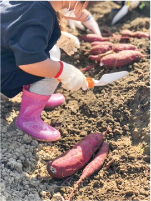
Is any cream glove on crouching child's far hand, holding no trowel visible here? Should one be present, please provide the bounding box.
[57,31,80,55]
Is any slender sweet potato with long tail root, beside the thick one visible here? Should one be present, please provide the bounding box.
[69,142,109,201]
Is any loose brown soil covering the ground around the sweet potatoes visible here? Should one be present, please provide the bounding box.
[0,0,151,201]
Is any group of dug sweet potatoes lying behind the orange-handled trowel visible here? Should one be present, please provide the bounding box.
[80,30,149,68]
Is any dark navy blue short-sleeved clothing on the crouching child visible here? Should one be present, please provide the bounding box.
[0,0,61,98]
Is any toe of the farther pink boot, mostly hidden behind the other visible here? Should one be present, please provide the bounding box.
[45,93,65,108]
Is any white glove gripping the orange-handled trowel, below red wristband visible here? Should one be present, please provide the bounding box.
[58,61,88,91]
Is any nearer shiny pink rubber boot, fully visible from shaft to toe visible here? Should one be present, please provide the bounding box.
[16,86,60,142]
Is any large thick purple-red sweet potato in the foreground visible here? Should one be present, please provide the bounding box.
[47,133,103,178]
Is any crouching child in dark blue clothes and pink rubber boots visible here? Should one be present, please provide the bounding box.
[0,0,89,141]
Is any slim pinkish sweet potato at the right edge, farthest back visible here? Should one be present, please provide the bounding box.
[121,30,151,39]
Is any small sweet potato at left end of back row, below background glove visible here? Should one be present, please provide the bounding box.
[80,34,109,42]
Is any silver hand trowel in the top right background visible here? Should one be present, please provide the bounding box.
[112,0,131,25]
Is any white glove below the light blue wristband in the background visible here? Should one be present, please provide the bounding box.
[83,15,101,36]
